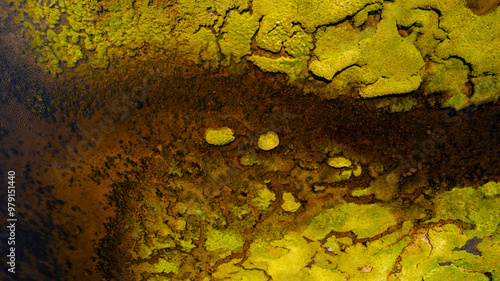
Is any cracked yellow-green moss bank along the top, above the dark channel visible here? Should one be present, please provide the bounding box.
[9,0,500,111]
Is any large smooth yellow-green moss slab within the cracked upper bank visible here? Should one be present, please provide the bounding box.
[309,3,424,98]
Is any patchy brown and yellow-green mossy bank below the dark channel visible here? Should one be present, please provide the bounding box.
[98,134,500,281]
